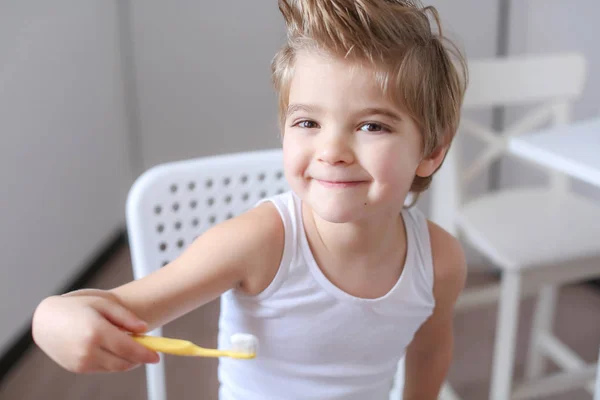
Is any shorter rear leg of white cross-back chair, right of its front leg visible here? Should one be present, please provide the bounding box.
[525,285,558,380]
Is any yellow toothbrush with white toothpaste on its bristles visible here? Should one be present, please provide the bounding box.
[131,333,258,360]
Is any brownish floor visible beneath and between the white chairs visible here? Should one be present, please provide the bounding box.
[0,248,600,400]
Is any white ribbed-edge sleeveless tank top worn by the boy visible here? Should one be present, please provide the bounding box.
[219,192,435,400]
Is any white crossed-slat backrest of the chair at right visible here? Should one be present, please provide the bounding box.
[431,53,586,234]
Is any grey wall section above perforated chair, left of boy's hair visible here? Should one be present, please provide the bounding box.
[131,0,284,168]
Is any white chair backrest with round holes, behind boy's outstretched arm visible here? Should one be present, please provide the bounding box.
[127,149,288,279]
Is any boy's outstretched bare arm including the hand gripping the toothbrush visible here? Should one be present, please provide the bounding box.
[32,203,284,373]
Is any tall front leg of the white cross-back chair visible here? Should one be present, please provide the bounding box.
[489,271,521,400]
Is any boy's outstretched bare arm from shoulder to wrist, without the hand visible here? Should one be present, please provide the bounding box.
[110,203,284,329]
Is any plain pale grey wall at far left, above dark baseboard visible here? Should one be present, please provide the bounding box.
[0,0,131,353]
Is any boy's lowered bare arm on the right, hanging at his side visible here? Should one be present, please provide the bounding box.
[403,223,466,400]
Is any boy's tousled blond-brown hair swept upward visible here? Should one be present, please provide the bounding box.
[271,0,467,194]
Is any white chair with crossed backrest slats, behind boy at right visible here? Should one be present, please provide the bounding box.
[431,53,600,400]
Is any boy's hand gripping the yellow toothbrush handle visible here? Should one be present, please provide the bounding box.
[32,295,159,373]
